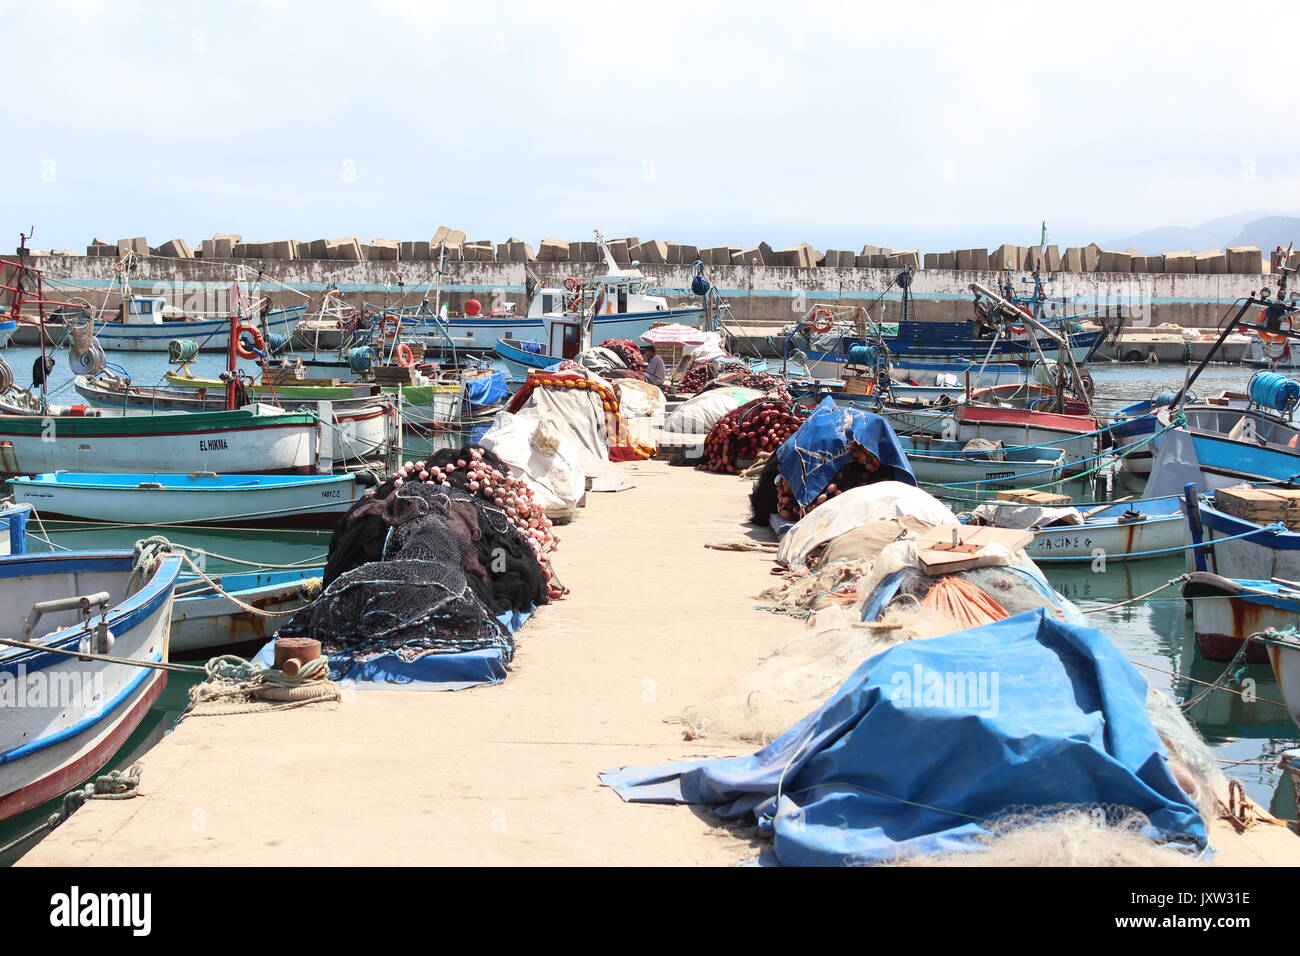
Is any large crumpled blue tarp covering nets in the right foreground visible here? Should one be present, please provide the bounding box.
[601,610,1206,865]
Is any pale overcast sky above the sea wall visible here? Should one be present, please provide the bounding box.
[0,0,1300,250]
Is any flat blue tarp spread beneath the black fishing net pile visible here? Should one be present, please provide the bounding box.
[254,611,533,691]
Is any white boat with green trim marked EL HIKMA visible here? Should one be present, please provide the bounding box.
[0,405,335,479]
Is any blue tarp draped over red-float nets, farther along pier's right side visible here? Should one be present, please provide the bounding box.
[776,397,917,506]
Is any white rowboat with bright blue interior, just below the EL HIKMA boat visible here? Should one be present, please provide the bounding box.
[9,472,365,528]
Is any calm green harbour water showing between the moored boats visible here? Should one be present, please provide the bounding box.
[0,349,1300,865]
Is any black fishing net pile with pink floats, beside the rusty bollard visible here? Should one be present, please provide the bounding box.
[280,445,553,659]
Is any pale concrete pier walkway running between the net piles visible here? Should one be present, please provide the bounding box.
[20,462,1300,866]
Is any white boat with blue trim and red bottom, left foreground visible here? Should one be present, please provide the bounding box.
[0,551,181,819]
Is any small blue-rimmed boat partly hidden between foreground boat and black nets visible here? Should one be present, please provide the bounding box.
[172,567,321,659]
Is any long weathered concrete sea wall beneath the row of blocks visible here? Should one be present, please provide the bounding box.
[12,255,1277,328]
